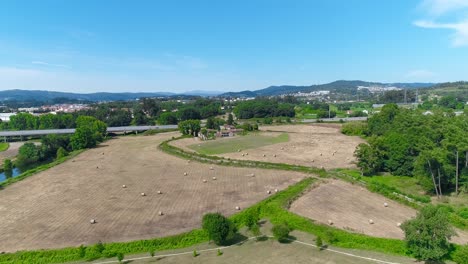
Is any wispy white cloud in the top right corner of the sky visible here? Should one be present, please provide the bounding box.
[413,0,468,47]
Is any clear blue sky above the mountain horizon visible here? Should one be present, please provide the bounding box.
[0,0,468,92]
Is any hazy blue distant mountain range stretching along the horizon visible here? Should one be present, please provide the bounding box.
[0,81,436,102]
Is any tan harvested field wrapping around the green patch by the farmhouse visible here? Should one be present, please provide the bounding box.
[171,124,365,169]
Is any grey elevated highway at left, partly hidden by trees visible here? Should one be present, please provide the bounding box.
[0,125,177,137]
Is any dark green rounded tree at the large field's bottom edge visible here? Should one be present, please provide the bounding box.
[202,213,237,245]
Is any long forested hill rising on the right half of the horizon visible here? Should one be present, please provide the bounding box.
[221,80,435,97]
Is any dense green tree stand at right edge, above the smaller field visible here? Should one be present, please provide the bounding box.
[354,104,468,196]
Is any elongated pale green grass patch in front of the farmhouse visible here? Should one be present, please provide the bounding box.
[189,133,289,155]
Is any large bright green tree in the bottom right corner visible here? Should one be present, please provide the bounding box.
[401,205,454,261]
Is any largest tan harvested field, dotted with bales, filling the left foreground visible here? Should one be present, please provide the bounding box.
[0,132,306,252]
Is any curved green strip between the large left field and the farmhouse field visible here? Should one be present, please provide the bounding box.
[159,137,327,177]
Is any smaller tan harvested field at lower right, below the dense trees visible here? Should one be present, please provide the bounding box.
[290,180,468,243]
